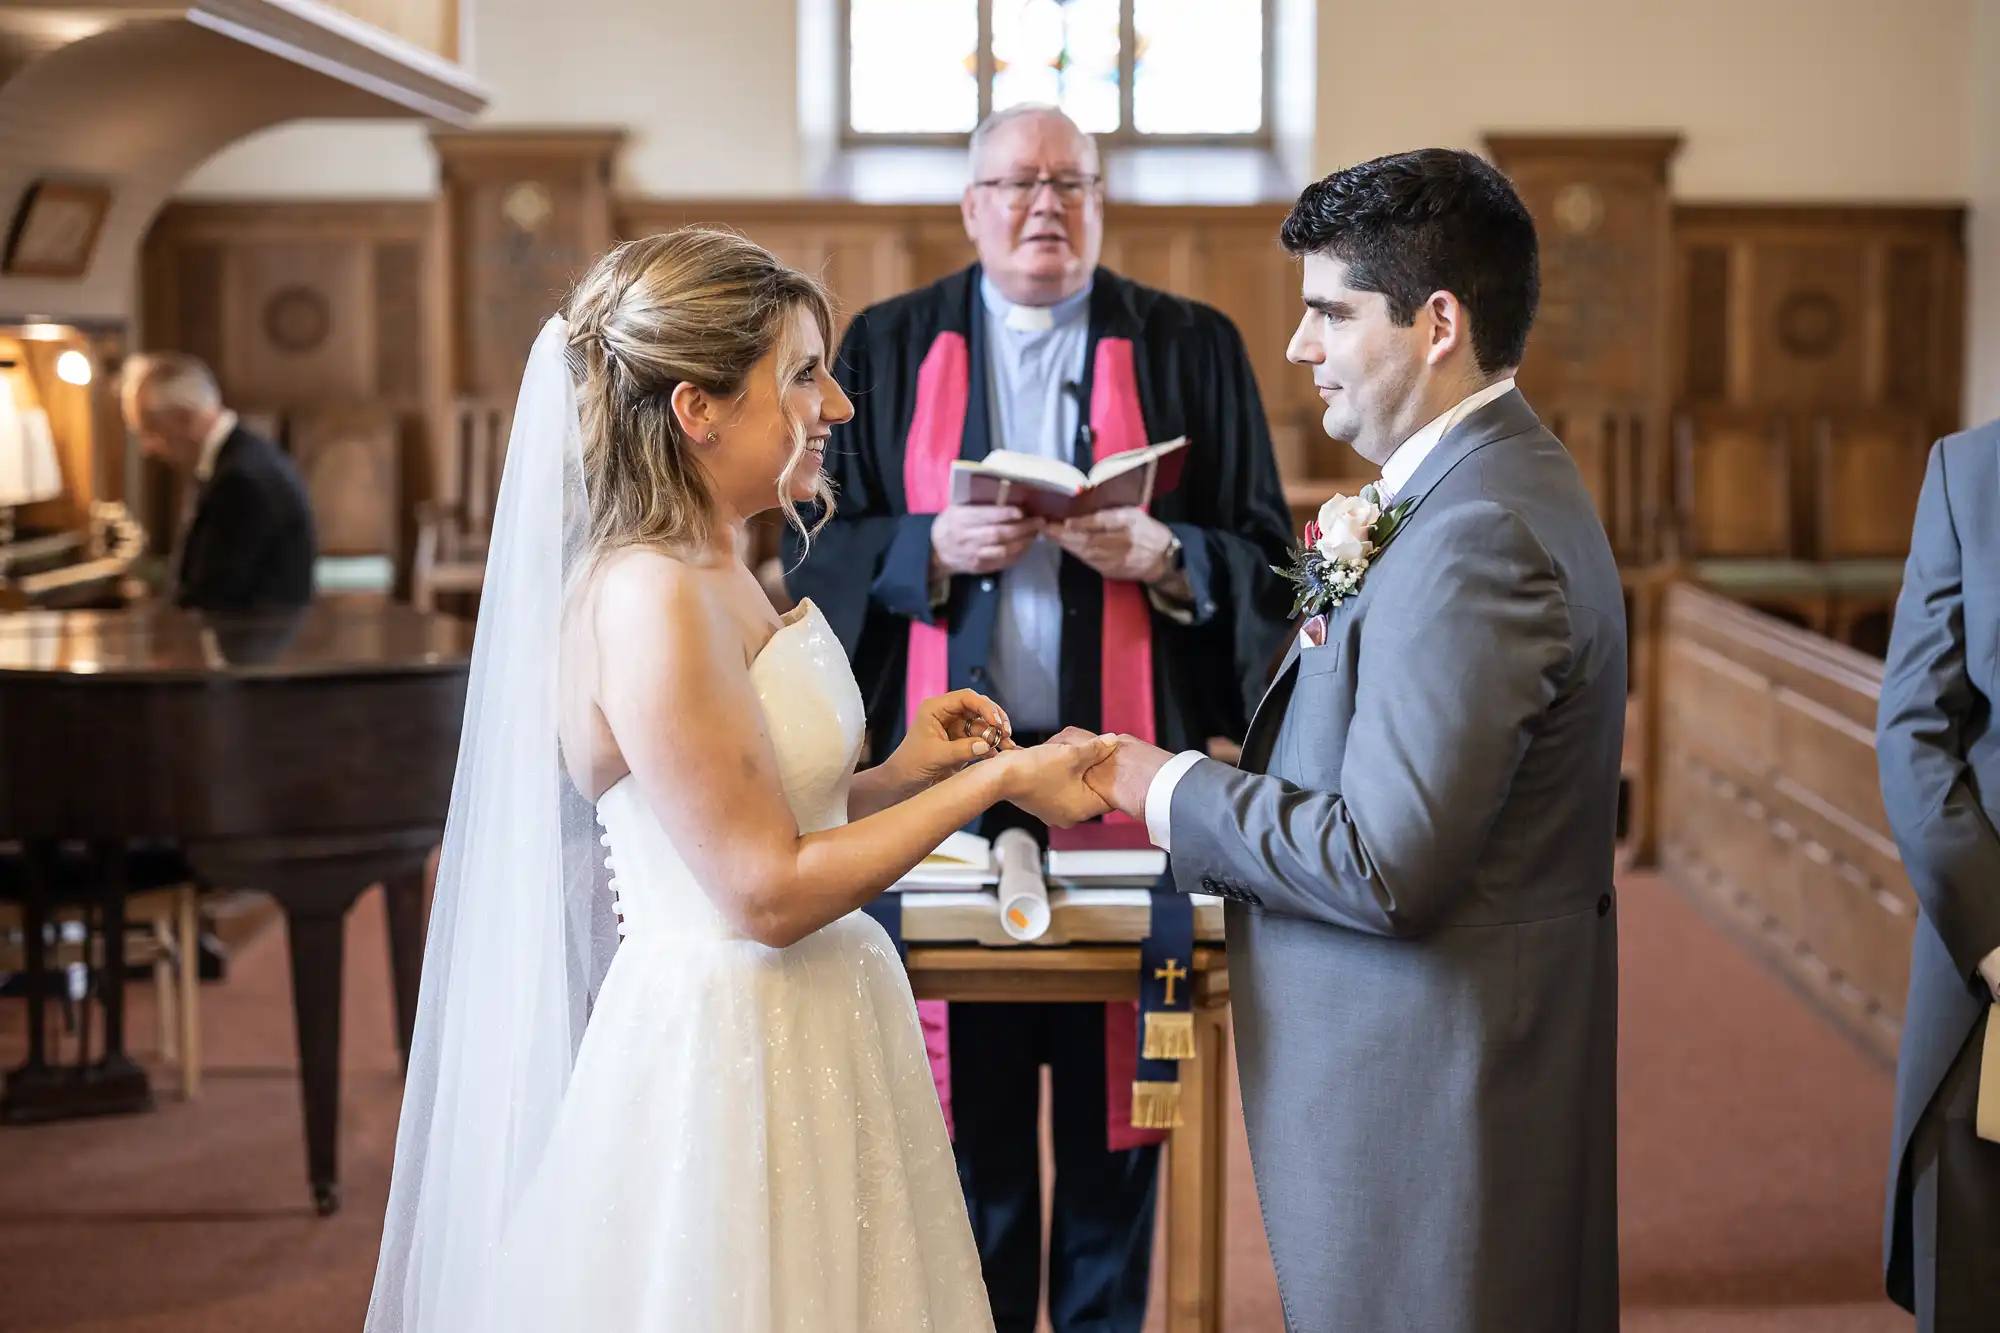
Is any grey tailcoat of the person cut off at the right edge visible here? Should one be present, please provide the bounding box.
[1876,422,2000,1307]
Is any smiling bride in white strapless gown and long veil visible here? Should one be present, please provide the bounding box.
[368,230,1112,1333]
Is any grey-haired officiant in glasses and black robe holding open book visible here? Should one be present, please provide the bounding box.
[786,106,1290,1333]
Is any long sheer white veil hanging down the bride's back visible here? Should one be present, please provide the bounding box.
[366,316,616,1333]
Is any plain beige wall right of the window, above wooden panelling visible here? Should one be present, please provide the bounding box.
[1316,0,1984,200]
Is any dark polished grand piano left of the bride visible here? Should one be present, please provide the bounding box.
[0,600,472,1215]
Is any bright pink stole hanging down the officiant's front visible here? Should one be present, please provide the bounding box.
[902,332,1166,1151]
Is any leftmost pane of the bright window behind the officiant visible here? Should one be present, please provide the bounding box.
[848,0,982,134]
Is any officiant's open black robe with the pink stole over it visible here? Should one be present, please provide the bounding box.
[786,266,1292,1147]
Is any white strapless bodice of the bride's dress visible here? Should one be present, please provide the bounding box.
[598,600,866,939]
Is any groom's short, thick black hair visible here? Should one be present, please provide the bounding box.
[1278,148,1542,374]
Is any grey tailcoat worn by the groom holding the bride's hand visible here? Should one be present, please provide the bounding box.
[1170,394,1626,1333]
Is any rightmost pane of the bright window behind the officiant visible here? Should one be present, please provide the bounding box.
[1132,0,1264,134]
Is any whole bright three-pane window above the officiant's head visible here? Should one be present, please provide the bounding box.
[840,0,1270,142]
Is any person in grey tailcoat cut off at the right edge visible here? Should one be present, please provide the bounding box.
[1876,422,2000,1333]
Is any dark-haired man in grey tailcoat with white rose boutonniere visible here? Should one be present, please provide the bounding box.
[1090,150,1626,1333]
